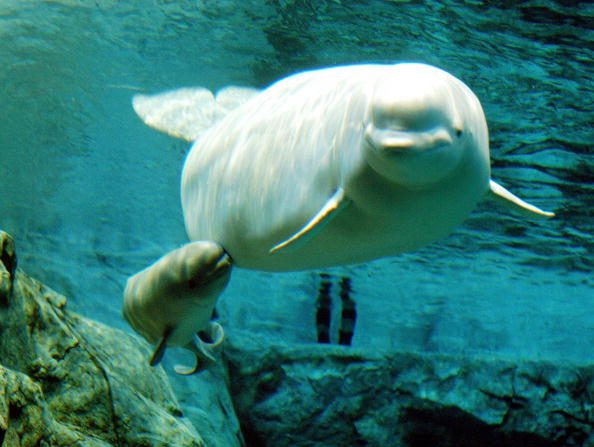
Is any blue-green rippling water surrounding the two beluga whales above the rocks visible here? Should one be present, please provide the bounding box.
[0,0,594,372]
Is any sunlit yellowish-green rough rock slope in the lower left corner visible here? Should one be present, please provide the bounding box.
[0,232,205,447]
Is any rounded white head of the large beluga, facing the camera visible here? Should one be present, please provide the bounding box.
[358,64,470,188]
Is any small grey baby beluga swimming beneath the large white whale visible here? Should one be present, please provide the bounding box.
[123,241,231,374]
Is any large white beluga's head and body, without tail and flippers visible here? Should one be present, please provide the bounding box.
[181,64,490,271]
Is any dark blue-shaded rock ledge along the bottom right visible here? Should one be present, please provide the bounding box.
[226,330,594,447]
